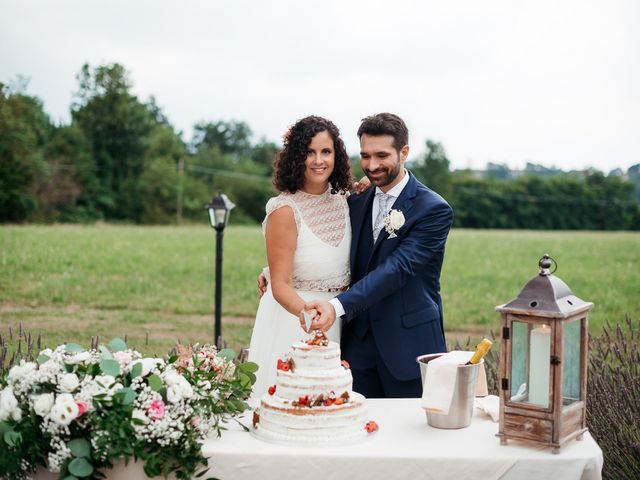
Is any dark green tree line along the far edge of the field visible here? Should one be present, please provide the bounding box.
[0,63,640,230]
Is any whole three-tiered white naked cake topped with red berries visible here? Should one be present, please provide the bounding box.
[253,332,377,445]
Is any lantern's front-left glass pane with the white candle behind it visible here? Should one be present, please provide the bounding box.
[511,321,551,408]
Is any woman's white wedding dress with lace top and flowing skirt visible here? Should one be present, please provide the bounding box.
[249,188,351,399]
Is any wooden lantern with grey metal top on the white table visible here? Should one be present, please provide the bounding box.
[496,254,593,453]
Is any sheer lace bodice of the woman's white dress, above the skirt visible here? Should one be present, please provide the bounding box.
[262,188,351,292]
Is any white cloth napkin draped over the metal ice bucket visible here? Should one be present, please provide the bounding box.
[422,350,473,415]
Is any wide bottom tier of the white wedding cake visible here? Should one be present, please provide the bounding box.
[253,392,368,445]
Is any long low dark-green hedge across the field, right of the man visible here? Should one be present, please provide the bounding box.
[449,172,640,230]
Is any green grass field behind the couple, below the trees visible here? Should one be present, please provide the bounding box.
[0,225,640,354]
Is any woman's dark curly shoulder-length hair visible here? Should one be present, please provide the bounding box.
[273,115,353,194]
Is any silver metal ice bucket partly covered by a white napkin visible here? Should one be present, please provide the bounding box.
[416,353,484,428]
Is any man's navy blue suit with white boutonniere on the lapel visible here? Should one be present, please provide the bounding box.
[338,175,453,397]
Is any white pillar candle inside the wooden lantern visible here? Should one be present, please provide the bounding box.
[529,325,551,407]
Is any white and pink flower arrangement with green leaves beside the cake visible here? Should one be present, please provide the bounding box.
[0,339,257,479]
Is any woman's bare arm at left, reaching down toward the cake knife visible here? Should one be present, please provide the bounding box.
[265,206,304,317]
